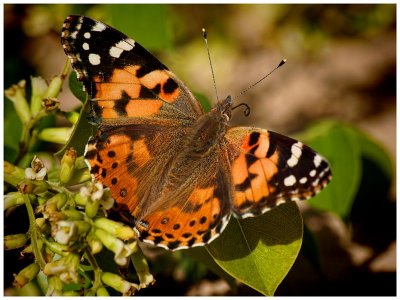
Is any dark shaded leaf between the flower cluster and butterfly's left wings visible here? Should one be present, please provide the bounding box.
[56,99,95,156]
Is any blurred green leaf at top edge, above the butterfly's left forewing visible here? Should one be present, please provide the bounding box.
[104,4,172,50]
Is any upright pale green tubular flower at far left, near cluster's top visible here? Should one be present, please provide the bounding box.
[4,80,31,124]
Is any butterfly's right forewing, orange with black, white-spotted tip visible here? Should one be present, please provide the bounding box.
[226,127,331,218]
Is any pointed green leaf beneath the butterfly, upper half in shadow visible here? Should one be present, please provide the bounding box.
[207,203,303,295]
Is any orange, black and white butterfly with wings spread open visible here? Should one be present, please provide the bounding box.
[61,16,331,250]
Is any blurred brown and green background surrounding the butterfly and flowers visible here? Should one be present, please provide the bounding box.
[4,4,396,296]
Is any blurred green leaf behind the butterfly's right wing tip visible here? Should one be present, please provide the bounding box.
[301,121,362,219]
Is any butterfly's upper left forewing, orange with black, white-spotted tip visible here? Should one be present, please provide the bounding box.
[61,16,203,125]
